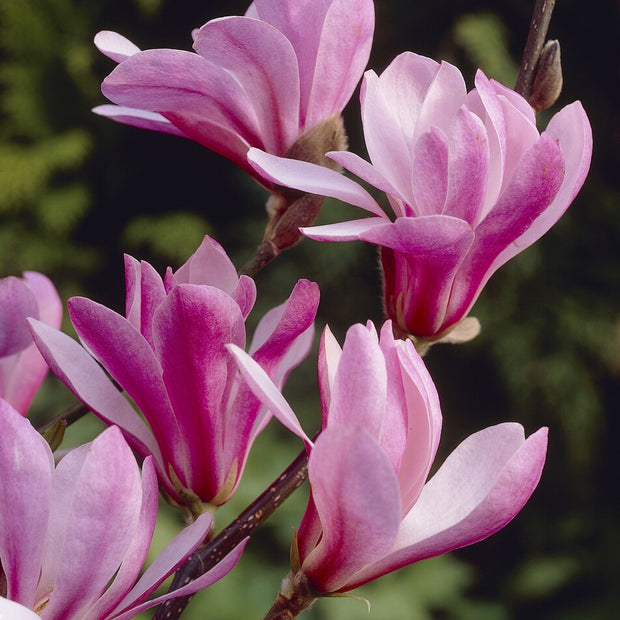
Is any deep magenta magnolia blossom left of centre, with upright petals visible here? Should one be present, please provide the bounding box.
[31,237,319,514]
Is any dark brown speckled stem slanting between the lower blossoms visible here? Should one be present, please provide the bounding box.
[153,450,308,620]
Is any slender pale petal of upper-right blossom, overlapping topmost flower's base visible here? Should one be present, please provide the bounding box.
[248,149,387,219]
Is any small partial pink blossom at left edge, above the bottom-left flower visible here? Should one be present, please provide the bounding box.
[0,271,62,415]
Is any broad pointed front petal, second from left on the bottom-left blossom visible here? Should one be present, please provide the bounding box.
[39,427,142,618]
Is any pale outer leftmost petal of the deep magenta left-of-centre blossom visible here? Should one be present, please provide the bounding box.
[30,319,165,472]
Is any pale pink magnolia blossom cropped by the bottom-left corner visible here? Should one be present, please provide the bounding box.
[0,399,245,620]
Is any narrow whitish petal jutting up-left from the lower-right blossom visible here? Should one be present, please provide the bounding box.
[226,344,312,445]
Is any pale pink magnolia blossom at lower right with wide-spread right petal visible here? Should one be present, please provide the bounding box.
[231,321,547,617]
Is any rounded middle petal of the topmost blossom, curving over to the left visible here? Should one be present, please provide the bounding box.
[194,17,300,155]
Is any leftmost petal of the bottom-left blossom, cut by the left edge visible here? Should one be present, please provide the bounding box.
[0,399,54,617]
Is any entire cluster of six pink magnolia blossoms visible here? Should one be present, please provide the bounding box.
[0,0,592,620]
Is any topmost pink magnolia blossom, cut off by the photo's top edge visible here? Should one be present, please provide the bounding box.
[94,0,374,183]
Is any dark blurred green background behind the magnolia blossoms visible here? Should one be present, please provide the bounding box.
[0,0,620,620]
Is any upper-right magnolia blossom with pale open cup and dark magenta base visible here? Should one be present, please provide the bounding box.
[248,53,592,340]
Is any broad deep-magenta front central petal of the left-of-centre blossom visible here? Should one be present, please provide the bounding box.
[153,284,246,501]
